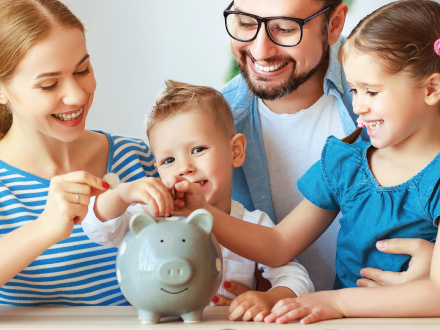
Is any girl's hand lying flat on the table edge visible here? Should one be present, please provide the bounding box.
[264,291,344,324]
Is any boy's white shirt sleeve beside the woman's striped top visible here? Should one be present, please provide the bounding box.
[81,196,148,247]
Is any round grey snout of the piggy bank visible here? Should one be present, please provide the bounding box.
[158,259,192,285]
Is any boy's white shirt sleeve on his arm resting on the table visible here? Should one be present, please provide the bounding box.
[252,211,315,296]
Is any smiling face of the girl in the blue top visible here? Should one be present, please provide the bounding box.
[343,51,438,148]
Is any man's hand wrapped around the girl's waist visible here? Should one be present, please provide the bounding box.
[356,238,434,287]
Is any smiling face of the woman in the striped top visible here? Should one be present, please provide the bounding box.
[0,27,96,142]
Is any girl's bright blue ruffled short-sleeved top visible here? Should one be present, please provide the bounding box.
[297,136,440,289]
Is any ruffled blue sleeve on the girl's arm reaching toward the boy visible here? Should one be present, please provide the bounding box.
[297,136,369,211]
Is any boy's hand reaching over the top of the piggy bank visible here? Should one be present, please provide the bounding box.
[111,177,174,217]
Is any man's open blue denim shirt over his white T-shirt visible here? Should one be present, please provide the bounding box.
[222,37,357,219]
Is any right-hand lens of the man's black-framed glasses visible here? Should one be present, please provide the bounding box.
[268,18,301,46]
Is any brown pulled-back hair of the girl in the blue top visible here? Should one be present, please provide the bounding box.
[339,0,440,140]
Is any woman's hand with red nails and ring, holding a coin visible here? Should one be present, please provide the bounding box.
[36,171,108,243]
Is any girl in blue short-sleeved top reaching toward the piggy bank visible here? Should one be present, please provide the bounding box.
[175,0,440,323]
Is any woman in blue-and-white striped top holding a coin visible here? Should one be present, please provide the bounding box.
[0,0,165,305]
